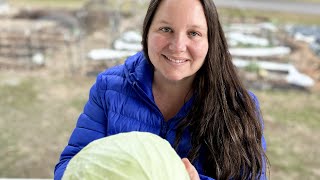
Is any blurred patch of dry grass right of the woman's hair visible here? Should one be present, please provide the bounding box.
[256,91,320,180]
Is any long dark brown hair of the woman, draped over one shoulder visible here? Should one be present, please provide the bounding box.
[142,0,267,180]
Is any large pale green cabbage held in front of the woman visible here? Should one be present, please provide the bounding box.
[63,132,190,180]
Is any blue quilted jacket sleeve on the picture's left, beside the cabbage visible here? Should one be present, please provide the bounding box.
[54,75,107,180]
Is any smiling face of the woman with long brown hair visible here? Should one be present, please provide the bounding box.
[147,0,208,81]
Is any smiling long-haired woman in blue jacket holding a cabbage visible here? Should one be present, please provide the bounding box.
[55,0,266,180]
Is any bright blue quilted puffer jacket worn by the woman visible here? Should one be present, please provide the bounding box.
[54,52,266,180]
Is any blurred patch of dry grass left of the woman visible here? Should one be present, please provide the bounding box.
[0,69,93,178]
